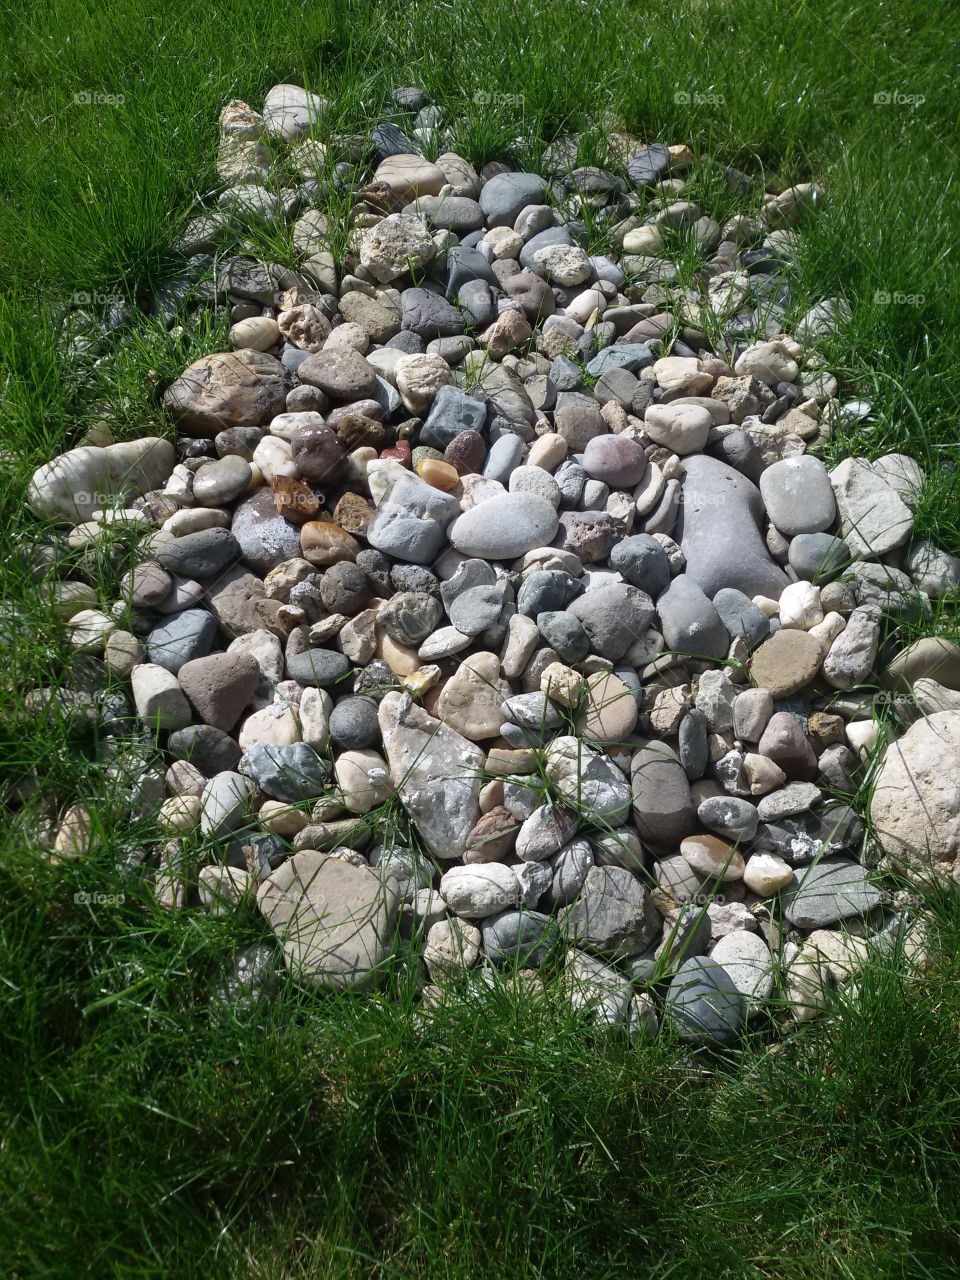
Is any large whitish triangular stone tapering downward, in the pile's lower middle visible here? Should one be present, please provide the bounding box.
[379,692,485,860]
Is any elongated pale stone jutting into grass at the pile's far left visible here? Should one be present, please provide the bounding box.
[27,435,175,524]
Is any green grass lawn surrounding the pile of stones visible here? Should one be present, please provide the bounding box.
[0,0,960,1280]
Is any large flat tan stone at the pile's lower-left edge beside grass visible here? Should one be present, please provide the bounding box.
[257,849,399,991]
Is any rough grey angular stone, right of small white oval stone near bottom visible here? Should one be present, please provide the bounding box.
[562,867,660,956]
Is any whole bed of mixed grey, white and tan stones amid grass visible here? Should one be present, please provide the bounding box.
[29,77,960,1044]
